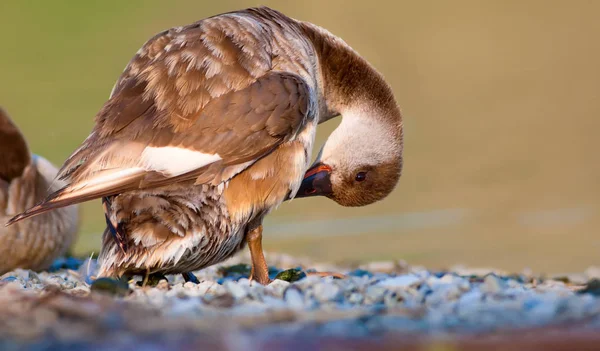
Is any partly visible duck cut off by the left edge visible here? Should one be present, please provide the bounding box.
[0,108,79,275]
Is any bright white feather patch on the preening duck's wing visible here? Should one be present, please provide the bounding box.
[141,146,221,177]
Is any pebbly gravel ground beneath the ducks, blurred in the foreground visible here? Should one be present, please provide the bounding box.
[0,254,600,350]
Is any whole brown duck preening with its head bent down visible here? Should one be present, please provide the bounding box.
[7,7,403,284]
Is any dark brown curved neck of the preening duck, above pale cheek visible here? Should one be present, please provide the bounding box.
[301,22,402,134]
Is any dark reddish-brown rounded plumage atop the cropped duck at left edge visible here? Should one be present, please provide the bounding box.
[0,108,31,183]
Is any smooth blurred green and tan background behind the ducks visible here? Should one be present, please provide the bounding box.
[0,0,600,272]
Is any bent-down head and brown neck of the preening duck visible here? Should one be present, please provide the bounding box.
[295,22,403,206]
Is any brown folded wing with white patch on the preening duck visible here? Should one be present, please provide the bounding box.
[7,16,315,225]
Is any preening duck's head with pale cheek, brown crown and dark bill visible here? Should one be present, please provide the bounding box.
[295,107,402,206]
